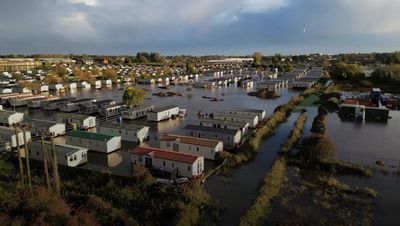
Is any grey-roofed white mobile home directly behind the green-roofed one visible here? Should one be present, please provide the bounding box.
[97,123,150,143]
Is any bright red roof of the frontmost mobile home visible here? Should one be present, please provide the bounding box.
[132,147,200,164]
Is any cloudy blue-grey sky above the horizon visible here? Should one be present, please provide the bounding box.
[0,0,400,55]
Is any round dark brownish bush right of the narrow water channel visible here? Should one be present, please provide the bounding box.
[299,134,336,162]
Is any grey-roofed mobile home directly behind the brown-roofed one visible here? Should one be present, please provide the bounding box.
[184,125,242,149]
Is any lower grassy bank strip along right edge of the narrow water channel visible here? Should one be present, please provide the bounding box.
[239,157,286,226]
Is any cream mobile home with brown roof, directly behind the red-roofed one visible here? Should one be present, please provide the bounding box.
[160,134,224,160]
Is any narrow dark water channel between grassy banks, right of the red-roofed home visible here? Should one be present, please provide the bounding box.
[204,113,299,225]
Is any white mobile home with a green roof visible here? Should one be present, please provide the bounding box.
[65,130,121,153]
